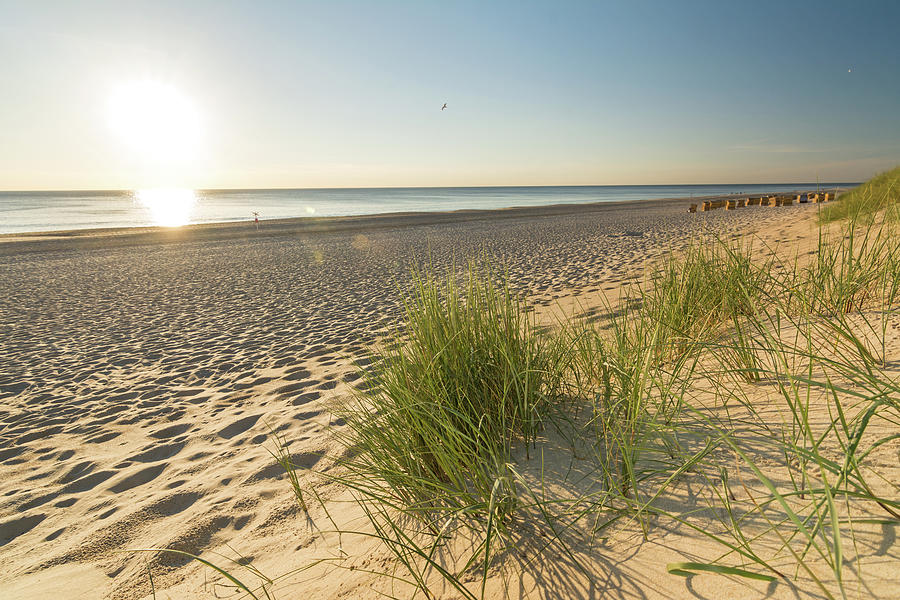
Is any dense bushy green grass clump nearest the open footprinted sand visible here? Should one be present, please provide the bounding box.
[341,265,560,520]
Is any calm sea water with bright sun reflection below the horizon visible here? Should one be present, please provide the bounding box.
[0,183,856,233]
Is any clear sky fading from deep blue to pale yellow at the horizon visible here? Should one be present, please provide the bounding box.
[0,0,900,190]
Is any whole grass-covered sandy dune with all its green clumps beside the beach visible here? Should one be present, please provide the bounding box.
[141,171,900,600]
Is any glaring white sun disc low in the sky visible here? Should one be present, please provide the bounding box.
[109,80,200,162]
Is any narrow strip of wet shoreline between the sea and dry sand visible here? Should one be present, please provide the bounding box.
[0,188,839,256]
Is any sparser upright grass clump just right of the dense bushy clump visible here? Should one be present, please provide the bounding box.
[562,274,710,508]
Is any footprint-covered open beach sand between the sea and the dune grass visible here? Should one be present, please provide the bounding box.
[0,200,900,599]
